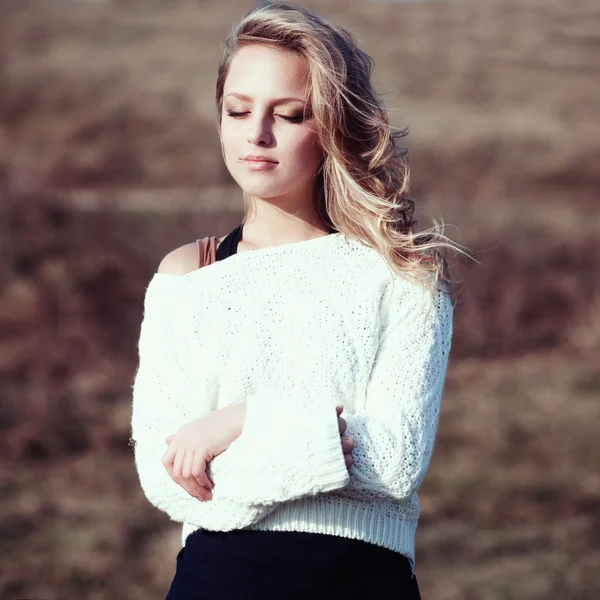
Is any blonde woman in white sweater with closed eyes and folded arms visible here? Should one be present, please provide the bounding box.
[132,4,460,600]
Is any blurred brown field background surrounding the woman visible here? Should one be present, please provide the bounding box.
[0,0,600,600]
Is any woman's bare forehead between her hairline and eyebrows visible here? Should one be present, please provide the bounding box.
[224,44,308,99]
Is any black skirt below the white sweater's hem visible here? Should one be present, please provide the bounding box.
[166,529,421,600]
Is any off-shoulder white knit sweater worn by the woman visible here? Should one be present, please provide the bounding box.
[131,233,453,567]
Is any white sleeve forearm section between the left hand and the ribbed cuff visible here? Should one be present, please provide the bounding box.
[209,388,350,505]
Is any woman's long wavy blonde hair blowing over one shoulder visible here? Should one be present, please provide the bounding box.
[216,3,466,312]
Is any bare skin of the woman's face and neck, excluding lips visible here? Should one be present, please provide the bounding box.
[221,45,329,252]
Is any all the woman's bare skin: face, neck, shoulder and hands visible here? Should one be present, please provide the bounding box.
[158,45,354,500]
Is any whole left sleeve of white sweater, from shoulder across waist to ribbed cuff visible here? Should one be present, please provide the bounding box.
[131,274,349,531]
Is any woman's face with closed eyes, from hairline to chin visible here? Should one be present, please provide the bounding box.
[221,45,322,199]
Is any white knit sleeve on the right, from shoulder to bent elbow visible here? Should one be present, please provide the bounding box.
[338,286,453,499]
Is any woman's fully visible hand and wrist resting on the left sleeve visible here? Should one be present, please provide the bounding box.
[162,403,246,501]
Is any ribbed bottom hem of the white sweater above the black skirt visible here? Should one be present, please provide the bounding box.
[182,494,417,575]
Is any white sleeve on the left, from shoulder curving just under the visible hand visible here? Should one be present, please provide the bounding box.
[131,275,273,531]
